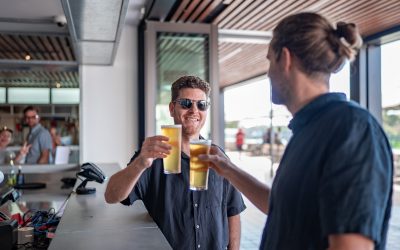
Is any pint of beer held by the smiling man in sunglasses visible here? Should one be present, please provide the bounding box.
[161,124,182,174]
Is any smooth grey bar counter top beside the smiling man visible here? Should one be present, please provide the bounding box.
[49,164,171,250]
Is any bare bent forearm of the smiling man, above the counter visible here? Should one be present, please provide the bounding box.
[104,158,145,203]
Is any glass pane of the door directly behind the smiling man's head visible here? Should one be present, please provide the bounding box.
[156,32,211,137]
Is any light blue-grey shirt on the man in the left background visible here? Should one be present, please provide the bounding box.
[25,124,53,164]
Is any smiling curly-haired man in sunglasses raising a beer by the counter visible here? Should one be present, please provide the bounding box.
[105,76,245,249]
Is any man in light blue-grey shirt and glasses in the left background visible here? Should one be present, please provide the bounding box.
[24,106,53,164]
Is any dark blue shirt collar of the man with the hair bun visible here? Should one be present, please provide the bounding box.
[289,93,346,134]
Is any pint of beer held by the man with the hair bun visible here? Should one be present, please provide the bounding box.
[189,140,211,190]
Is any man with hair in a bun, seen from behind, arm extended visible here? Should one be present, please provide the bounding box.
[200,13,393,250]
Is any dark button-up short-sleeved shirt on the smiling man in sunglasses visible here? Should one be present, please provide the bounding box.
[122,148,246,249]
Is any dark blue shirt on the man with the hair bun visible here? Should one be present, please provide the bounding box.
[260,93,393,250]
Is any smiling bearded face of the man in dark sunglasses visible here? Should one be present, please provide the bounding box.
[169,88,207,139]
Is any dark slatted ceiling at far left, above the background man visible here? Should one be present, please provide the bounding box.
[0,33,79,88]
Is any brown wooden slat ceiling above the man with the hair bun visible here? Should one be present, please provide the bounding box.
[165,0,400,87]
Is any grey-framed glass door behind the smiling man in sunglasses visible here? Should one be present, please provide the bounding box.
[145,22,223,143]
